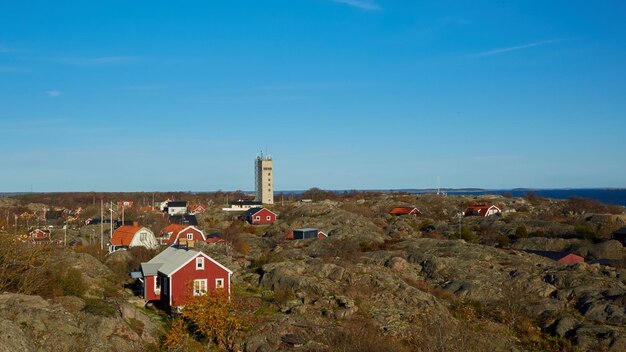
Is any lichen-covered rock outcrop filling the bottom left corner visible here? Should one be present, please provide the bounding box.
[0,293,158,352]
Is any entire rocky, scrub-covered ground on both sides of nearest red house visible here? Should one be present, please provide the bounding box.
[0,194,626,352]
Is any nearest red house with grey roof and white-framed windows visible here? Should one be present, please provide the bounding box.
[141,241,233,310]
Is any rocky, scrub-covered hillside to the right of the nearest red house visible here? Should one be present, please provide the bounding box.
[209,200,626,351]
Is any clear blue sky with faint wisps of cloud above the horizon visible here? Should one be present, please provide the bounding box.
[0,0,626,191]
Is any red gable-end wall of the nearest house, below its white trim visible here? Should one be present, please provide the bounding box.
[168,255,230,307]
